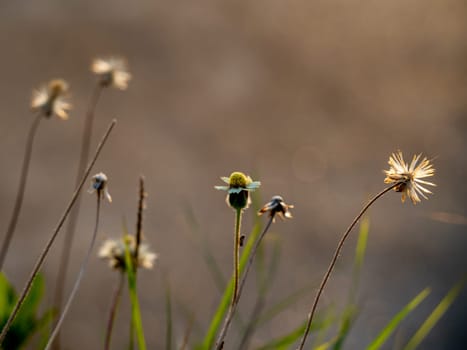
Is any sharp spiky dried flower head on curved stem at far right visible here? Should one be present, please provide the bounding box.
[384,151,436,204]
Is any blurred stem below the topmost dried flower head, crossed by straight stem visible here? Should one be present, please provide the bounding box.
[53,83,103,334]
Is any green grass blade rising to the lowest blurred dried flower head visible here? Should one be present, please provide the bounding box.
[125,241,146,350]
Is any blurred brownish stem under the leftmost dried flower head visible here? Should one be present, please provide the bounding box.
[0,112,44,271]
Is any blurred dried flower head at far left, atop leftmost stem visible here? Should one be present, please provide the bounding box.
[31,79,71,120]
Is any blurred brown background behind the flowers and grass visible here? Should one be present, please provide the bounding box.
[0,0,467,349]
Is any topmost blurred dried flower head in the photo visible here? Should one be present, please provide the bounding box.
[91,57,131,90]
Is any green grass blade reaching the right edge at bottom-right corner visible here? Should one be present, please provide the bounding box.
[404,278,466,350]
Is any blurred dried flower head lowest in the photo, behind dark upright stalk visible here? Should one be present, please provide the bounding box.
[98,235,157,271]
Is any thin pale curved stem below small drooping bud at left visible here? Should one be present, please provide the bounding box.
[45,196,102,350]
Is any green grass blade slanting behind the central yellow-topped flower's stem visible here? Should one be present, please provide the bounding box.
[201,225,261,350]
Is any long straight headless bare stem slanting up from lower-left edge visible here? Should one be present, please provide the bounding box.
[0,119,117,345]
